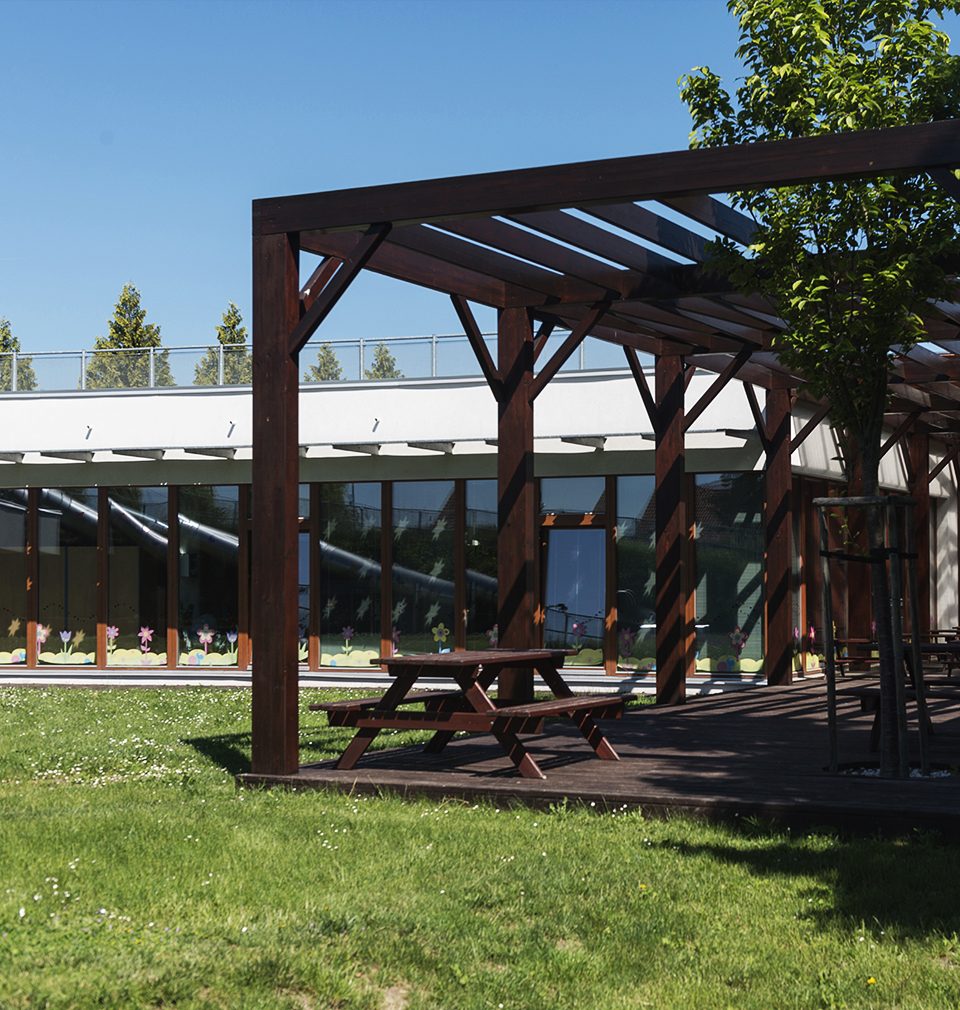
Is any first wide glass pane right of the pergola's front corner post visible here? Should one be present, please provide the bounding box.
[323,484,382,668]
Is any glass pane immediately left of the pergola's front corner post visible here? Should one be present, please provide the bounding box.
[178,485,239,667]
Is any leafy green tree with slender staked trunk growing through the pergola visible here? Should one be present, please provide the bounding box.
[680,0,960,770]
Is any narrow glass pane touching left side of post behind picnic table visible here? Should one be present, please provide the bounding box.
[465,481,498,648]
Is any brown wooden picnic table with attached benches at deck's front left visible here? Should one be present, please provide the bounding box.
[310,648,623,779]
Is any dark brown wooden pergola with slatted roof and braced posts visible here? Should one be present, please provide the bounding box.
[252,121,960,775]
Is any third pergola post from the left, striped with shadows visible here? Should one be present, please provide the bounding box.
[655,355,693,705]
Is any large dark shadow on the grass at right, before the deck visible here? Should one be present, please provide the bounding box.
[663,824,960,938]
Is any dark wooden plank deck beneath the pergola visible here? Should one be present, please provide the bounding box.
[239,680,960,837]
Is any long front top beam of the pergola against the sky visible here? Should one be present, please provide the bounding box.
[254,120,960,234]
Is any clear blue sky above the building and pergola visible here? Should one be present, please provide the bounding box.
[0,0,953,350]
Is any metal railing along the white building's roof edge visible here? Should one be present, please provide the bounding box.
[0,333,645,394]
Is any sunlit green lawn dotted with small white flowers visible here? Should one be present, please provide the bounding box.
[0,689,960,1010]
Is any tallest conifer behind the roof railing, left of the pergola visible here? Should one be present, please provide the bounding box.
[87,284,174,389]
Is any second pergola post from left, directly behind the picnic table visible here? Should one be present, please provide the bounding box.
[497,308,537,705]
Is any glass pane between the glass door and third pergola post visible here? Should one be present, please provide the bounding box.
[616,475,657,671]
